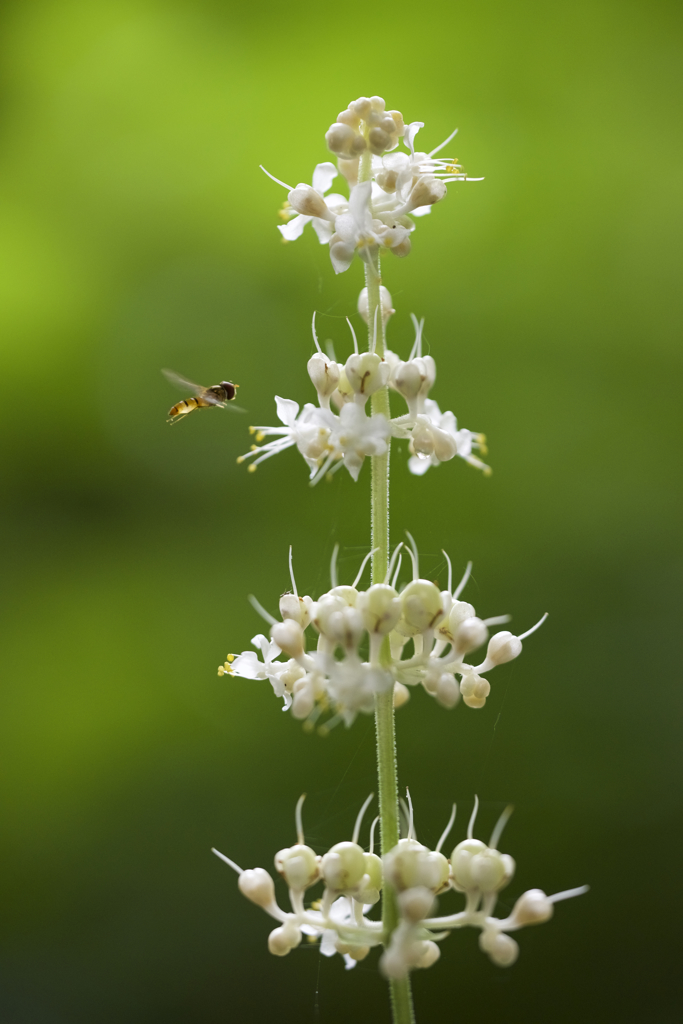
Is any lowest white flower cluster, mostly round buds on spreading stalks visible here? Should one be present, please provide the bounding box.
[213,794,588,979]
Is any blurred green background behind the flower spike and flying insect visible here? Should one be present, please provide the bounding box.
[0,0,683,1024]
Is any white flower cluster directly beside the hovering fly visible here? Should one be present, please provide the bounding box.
[238,299,490,483]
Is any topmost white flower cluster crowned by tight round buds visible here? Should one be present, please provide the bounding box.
[263,96,481,273]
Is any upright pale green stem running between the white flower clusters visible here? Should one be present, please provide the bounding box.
[359,155,415,1024]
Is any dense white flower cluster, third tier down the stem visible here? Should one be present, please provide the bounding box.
[218,534,546,732]
